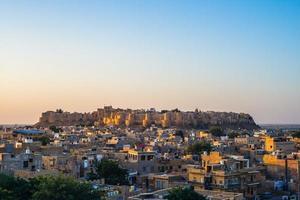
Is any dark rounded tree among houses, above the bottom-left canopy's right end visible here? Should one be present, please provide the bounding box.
[89,159,128,185]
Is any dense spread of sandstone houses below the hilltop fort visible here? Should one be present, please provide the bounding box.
[0,126,300,199]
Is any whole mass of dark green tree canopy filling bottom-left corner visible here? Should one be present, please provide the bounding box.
[0,174,101,200]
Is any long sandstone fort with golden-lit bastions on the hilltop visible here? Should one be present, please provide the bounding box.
[35,106,259,130]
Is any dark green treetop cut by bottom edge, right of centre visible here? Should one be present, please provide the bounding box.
[167,187,206,200]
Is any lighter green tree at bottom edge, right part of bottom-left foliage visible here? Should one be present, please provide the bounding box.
[30,176,100,200]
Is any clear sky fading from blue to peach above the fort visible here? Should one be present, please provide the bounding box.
[0,0,300,124]
